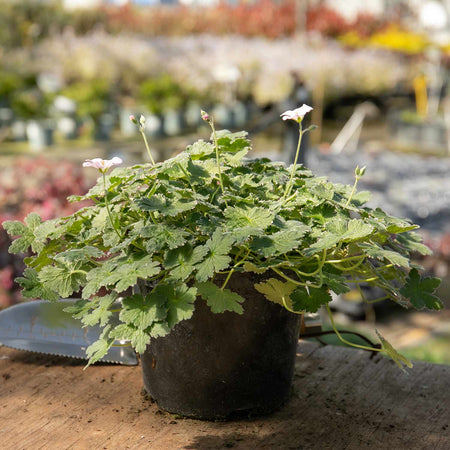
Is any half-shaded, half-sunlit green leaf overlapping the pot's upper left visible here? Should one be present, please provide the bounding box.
[151,284,197,328]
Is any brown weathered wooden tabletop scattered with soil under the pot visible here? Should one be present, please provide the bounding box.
[0,341,450,450]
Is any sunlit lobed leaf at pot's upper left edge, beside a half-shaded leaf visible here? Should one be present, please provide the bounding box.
[119,294,167,329]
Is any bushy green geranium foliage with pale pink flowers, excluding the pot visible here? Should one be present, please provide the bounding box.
[4,105,442,365]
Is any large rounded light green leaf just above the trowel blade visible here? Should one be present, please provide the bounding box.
[39,264,86,298]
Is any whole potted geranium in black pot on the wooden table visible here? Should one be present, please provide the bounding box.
[4,105,442,419]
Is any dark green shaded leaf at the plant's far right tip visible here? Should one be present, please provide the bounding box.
[400,269,444,309]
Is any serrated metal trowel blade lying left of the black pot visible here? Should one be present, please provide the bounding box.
[0,299,138,365]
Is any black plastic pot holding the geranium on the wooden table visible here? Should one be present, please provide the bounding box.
[141,275,300,420]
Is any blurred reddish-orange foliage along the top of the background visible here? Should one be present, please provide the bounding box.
[102,0,380,39]
